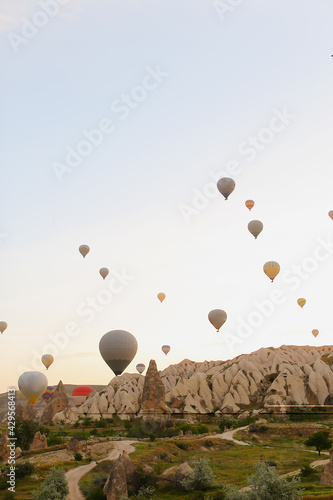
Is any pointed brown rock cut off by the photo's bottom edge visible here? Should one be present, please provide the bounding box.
[103,451,139,500]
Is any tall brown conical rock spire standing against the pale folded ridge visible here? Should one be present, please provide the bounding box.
[140,359,170,414]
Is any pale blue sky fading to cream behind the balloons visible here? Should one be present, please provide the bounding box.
[0,0,333,391]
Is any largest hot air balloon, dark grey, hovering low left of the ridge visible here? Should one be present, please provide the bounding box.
[99,330,138,375]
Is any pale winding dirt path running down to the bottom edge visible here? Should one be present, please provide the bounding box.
[66,441,135,500]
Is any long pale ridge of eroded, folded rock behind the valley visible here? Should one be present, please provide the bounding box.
[52,346,333,420]
